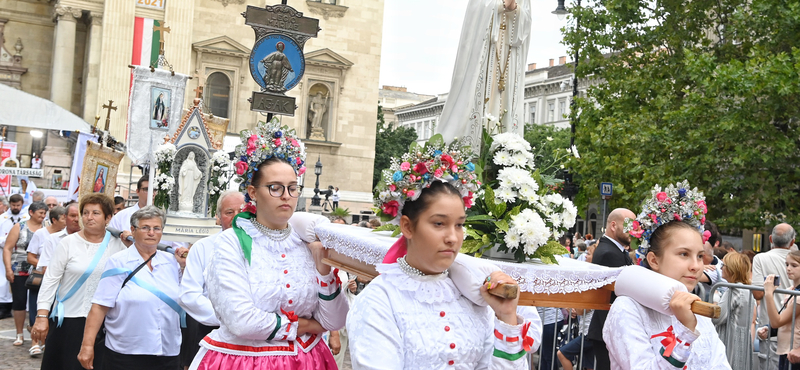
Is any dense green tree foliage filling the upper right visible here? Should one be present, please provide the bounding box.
[565,0,800,228]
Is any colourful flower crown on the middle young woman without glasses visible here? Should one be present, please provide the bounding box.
[375,134,481,224]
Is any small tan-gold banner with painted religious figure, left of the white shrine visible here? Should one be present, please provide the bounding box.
[80,142,125,197]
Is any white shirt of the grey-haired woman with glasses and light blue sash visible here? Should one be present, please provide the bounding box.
[92,246,181,356]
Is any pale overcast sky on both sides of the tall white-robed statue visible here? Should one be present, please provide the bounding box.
[380,0,572,95]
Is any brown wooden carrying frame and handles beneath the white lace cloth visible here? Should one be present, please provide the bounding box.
[323,249,720,319]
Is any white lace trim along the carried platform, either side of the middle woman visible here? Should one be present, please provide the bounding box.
[315,223,621,294]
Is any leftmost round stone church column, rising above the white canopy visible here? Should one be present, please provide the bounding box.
[50,5,82,110]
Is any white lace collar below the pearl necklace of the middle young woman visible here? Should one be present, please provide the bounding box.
[375,263,461,303]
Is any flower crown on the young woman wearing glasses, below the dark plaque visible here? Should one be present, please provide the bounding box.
[234,119,306,192]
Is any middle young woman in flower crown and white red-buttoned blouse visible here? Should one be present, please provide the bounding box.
[347,143,542,370]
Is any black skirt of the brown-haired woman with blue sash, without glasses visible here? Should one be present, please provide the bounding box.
[42,317,106,370]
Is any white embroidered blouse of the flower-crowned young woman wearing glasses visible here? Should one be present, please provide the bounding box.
[200,218,348,356]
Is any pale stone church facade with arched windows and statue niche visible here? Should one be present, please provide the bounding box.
[0,0,384,212]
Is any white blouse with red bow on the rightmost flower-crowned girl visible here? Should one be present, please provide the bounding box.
[603,297,731,370]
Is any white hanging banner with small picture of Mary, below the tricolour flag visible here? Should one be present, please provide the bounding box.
[127,66,189,164]
